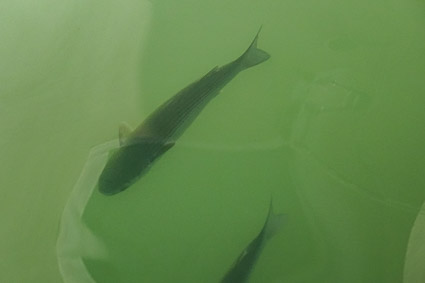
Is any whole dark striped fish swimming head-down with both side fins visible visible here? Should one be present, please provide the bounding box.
[98,31,270,195]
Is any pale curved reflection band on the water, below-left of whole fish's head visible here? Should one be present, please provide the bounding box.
[56,140,118,283]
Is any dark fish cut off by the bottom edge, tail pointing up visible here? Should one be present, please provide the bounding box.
[220,200,286,283]
